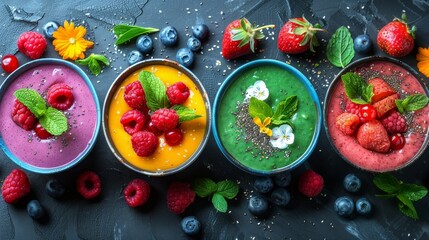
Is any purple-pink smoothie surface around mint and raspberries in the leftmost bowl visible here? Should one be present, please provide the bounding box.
[0,64,97,169]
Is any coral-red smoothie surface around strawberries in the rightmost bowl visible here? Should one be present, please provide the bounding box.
[326,61,429,172]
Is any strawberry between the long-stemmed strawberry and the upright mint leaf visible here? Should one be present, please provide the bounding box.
[277,16,326,54]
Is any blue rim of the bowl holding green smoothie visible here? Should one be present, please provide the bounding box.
[212,59,322,175]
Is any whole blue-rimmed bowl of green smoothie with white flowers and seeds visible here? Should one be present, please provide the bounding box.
[212,60,322,175]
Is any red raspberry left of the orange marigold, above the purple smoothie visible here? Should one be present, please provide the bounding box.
[17,32,47,59]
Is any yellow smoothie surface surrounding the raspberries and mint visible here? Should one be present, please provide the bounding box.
[108,65,207,172]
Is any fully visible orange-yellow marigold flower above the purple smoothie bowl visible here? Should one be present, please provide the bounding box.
[52,21,94,60]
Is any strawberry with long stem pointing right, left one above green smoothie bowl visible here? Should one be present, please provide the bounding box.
[222,18,274,60]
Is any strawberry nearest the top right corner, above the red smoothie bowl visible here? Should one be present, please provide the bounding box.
[377,13,416,57]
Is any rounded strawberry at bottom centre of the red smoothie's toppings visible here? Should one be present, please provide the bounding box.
[356,120,390,153]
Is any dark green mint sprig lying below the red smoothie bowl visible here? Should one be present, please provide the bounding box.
[373,173,428,220]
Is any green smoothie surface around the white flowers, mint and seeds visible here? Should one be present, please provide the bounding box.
[216,65,317,171]
